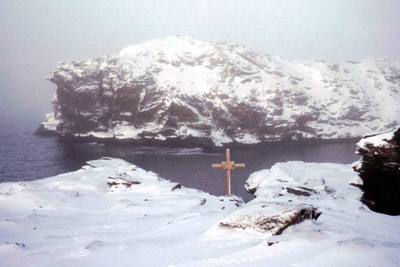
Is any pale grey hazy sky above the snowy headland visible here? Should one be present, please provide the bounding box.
[0,0,400,121]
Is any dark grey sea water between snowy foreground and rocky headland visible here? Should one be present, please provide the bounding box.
[0,119,359,201]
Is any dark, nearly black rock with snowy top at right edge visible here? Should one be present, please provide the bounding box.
[353,128,400,215]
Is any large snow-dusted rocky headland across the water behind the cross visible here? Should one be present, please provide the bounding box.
[41,36,400,149]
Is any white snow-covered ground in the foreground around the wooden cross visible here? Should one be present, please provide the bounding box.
[0,158,400,266]
